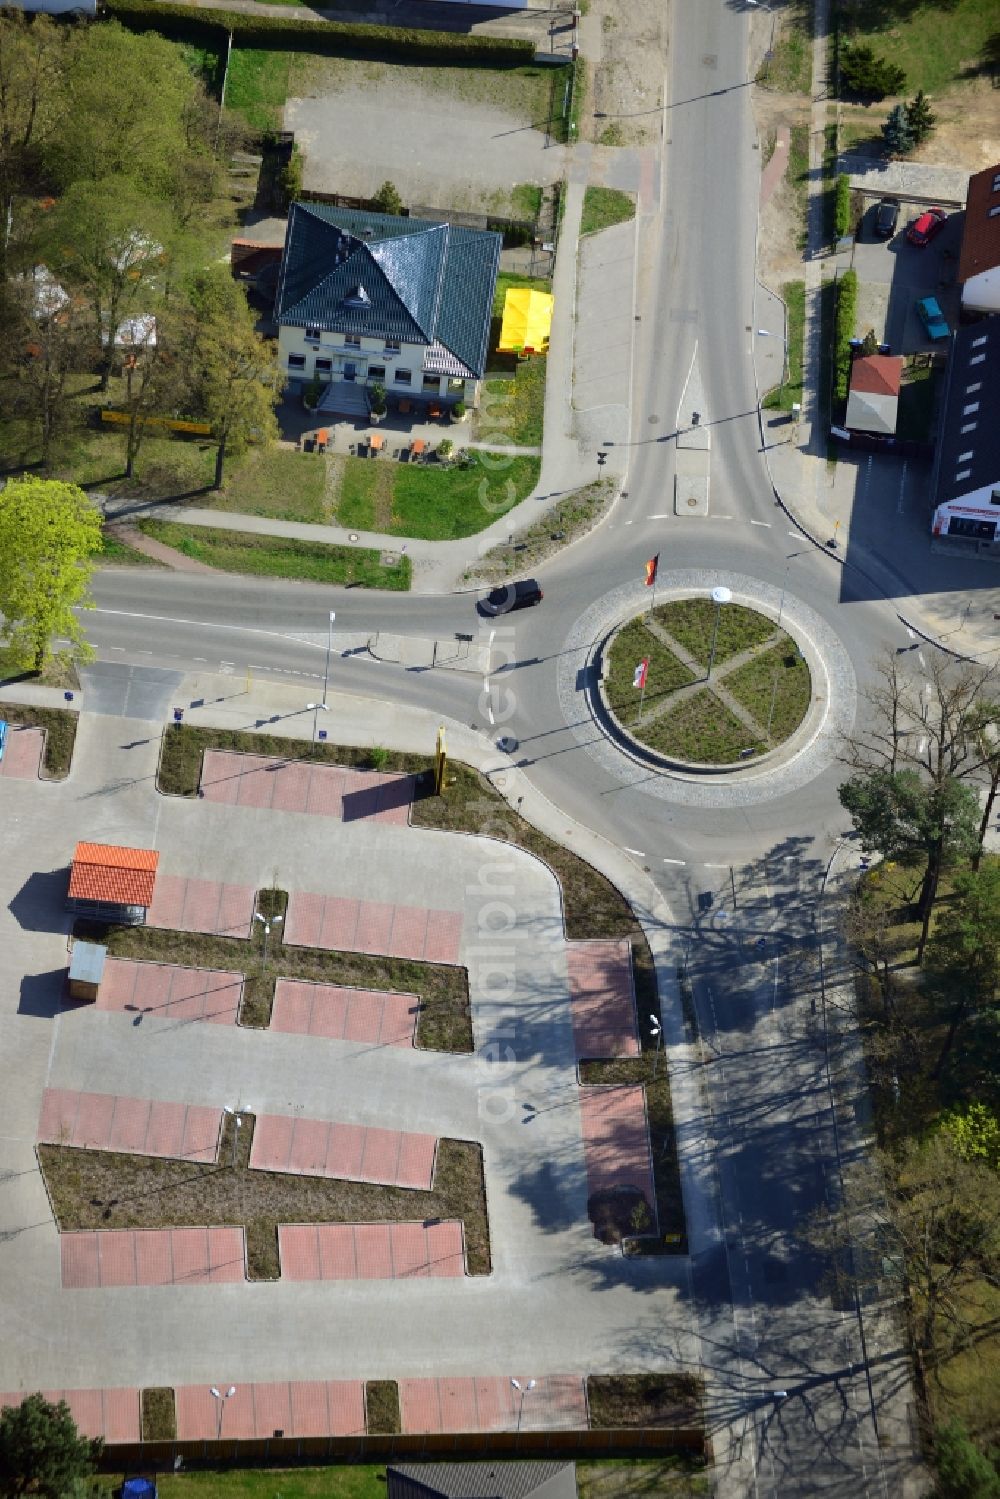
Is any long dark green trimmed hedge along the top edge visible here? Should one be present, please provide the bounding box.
[103,0,535,67]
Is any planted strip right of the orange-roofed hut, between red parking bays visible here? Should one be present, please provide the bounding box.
[76,889,472,1052]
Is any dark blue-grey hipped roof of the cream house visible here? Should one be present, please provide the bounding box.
[274,202,501,376]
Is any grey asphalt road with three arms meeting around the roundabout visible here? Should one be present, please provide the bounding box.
[70,0,909,1499]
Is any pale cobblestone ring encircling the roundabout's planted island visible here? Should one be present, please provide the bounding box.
[558,568,858,806]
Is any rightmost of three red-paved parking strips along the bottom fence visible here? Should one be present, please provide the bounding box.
[399,1373,588,1433]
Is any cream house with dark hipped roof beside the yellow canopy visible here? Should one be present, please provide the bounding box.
[274,202,501,406]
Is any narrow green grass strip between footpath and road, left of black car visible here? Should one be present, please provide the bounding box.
[138,520,411,592]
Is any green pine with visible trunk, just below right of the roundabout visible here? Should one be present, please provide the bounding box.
[838,769,979,961]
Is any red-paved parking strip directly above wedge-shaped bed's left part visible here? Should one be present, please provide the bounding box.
[37,1088,222,1162]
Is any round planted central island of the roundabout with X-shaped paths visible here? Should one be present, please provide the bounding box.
[600,588,813,769]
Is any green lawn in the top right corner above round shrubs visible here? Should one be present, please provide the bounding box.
[840,0,1000,97]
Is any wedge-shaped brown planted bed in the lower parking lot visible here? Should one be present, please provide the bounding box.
[37,1114,490,1280]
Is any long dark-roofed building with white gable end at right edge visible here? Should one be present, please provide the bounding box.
[933,318,1000,550]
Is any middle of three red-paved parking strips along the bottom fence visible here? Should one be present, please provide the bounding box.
[175,1370,364,1442]
